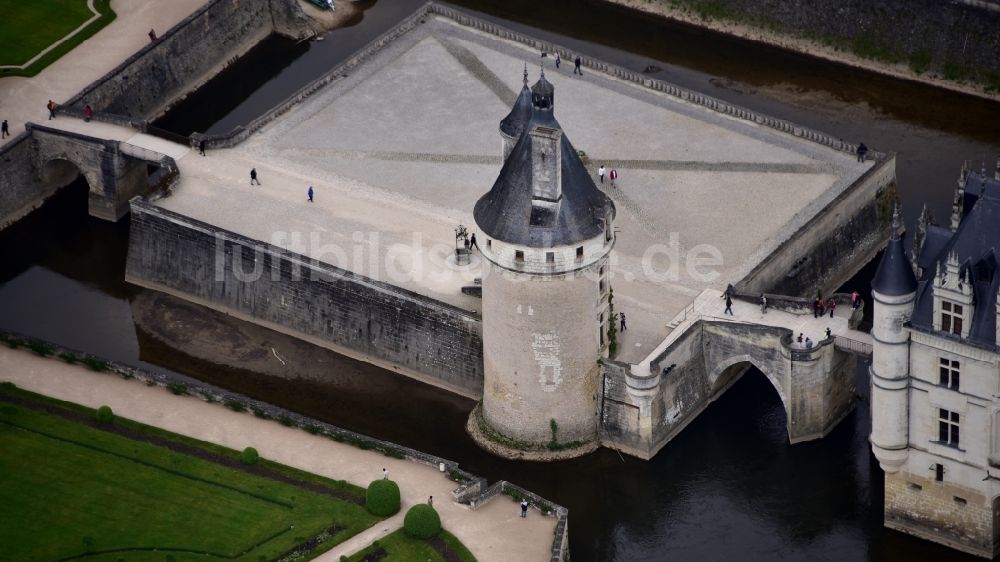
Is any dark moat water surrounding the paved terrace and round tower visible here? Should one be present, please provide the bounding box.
[0,0,1000,562]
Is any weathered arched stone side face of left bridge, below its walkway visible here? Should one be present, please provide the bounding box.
[25,123,177,222]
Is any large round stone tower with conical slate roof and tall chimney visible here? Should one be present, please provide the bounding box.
[474,71,615,448]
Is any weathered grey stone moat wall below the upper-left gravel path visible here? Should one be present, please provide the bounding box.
[62,0,312,119]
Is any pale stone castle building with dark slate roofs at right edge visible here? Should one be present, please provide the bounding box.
[871,162,1000,558]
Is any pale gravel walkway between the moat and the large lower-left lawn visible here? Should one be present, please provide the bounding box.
[0,347,556,562]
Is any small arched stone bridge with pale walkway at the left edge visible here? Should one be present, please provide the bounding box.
[0,123,180,227]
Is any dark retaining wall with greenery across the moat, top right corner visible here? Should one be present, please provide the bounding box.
[609,0,1000,97]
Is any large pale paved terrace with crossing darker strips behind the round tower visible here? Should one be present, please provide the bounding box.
[13,16,872,363]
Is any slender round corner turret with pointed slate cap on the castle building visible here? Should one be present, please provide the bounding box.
[870,203,917,473]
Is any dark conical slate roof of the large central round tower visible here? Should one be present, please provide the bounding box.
[473,78,615,248]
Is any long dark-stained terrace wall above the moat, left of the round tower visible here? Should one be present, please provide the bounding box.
[126,200,483,398]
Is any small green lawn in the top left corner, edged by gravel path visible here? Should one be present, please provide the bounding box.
[0,0,116,77]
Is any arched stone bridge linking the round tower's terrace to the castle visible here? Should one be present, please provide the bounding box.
[601,291,871,458]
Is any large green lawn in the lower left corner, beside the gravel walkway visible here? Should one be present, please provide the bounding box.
[0,385,378,562]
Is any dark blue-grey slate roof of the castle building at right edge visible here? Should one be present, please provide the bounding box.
[911,172,1000,345]
